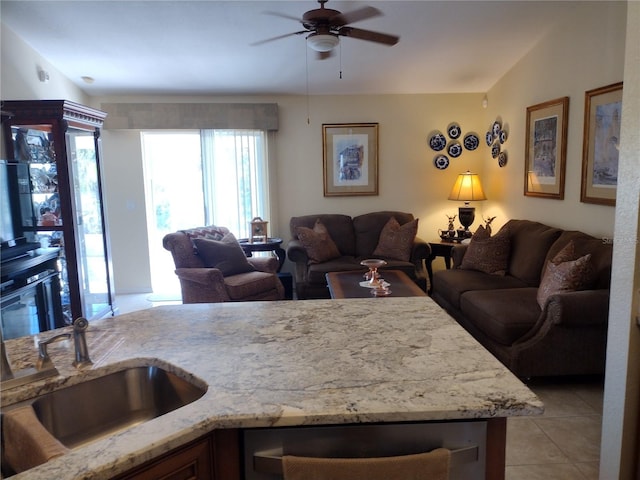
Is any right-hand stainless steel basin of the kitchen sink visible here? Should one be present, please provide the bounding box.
[3,366,207,448]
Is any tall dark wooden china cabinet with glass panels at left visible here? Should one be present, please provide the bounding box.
[2,100,114,327]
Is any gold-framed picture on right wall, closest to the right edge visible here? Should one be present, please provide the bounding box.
[580,82,622,205]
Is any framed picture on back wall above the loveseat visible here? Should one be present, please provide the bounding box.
[322,123,378,197]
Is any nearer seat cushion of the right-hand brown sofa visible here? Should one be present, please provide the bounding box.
[460,287,541,345]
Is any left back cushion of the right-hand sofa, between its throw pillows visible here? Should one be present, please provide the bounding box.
[501,220,562,287]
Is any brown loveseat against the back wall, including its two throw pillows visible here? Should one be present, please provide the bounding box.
[287,211,431,299]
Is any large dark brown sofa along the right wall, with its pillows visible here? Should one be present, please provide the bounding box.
[432,220,612,378]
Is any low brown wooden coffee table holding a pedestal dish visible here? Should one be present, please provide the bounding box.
[326,270,426,298]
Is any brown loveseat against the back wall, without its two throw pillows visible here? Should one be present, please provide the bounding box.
[287,211,431,299]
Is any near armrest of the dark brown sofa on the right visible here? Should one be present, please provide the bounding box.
[545,289,609,327]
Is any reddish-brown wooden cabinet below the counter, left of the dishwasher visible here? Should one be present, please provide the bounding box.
[114,430,241,480]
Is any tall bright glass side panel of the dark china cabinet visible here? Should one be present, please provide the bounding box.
[67,130,110,318]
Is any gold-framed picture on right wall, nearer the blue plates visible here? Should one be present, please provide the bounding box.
[524,97,569,200]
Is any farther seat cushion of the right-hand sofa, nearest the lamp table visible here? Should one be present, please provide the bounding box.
[433,268,527,308]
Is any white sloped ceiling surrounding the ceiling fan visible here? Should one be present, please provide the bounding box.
[0,0,580,95]
